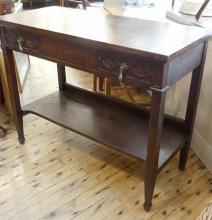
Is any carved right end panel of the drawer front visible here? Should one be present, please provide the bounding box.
[99,51,154,86]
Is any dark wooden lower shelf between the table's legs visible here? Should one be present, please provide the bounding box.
[22,88,186,168]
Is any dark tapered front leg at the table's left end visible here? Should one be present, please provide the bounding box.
[2,46,25,144]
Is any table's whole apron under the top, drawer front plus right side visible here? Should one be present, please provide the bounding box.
[2,27,204,90]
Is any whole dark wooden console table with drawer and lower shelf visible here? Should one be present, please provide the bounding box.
[0,7,208,211]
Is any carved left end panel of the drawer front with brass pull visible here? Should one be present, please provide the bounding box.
[5,29,41,52]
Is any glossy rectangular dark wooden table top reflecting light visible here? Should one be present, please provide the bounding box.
[0,6,208,61]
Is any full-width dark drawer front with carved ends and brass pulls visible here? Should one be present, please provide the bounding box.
[4,29,154,87]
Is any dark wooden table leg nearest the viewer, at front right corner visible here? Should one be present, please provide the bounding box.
[144,90,166,211]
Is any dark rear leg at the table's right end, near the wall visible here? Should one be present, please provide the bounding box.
[179,43,207,170]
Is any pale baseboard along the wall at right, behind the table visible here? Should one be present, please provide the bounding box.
[191,130,212,173]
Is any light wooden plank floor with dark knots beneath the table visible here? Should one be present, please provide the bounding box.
[0,58,212,220]
